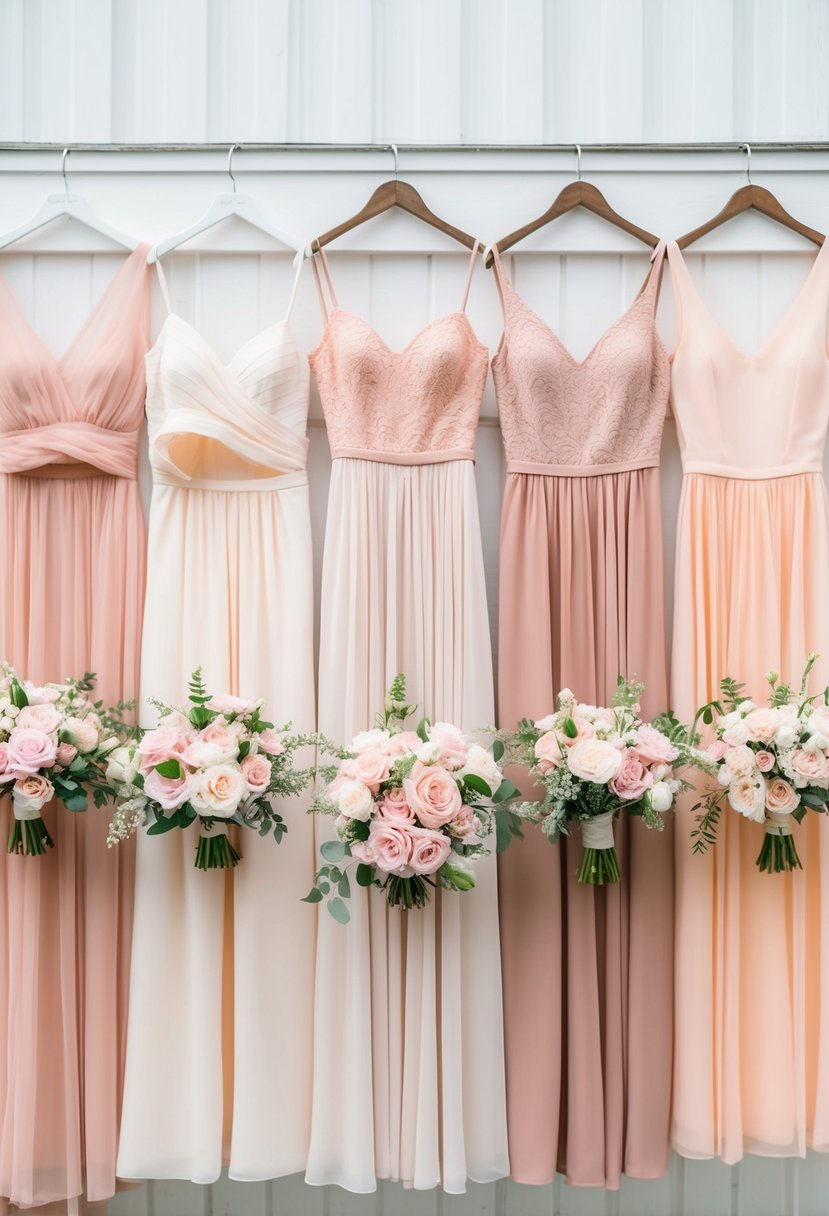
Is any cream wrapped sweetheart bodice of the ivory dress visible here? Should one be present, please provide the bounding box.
[147,314,309,490]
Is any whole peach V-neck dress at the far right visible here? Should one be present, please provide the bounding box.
[669,237,829,1162]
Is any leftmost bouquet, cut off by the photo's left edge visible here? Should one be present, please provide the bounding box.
[0,663,120,857]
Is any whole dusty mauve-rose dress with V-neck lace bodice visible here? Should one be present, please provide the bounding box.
[492,246,673,1188]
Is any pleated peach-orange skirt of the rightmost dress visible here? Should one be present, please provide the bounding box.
[672,473,829,1164]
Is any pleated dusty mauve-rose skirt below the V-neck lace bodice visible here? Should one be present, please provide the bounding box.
[498,468,673,1189]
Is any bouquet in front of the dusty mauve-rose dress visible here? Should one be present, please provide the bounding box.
[503,676,689,886]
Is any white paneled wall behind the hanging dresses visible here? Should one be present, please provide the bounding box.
[0,0,829,1216]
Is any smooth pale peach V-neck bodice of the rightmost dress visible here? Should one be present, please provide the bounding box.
[669,243,829,479]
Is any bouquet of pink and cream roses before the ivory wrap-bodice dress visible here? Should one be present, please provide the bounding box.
[107,668,316,869]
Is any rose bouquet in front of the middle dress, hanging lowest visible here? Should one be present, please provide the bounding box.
[305,675,518,924]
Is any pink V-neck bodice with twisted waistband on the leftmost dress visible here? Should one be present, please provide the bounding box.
[0,246,150,478]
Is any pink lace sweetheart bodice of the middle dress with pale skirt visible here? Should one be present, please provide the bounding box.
[309,244,487,465]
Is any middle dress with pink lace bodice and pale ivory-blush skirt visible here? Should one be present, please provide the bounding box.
[306,253,508,1193]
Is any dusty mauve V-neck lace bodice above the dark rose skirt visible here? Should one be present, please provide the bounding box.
[492,243,670,475]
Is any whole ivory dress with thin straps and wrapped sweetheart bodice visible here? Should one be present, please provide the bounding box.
[118,261,315,1182]
